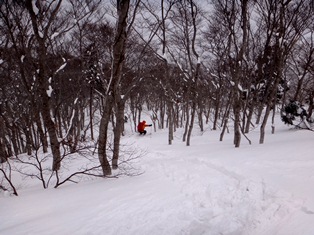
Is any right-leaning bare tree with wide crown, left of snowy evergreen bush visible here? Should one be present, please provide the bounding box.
[258,0,313,144]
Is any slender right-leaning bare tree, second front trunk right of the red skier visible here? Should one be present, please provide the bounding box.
[163,1,201,146]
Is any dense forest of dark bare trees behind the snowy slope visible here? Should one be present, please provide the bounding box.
[0,0,314,190]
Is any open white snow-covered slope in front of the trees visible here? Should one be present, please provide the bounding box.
[0,114,314,235]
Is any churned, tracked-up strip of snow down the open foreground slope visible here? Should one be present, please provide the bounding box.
[140,149,299,235]
